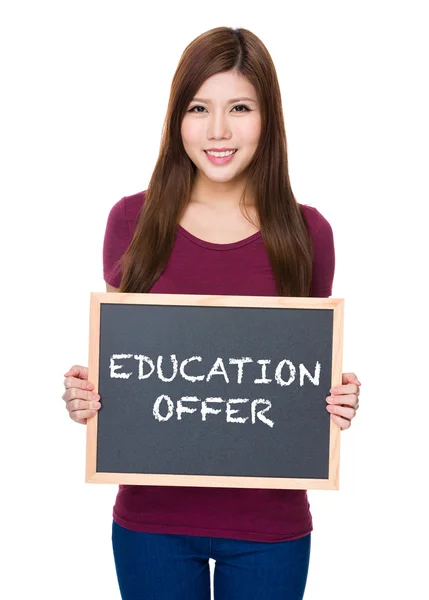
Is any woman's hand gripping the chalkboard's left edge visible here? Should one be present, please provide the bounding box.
[62,365,101,425]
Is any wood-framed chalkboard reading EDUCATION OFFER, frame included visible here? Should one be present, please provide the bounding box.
[86,293,344,489]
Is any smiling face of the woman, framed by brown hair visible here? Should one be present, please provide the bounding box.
[181,71,261,183]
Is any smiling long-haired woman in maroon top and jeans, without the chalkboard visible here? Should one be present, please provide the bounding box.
[63,27,360,600]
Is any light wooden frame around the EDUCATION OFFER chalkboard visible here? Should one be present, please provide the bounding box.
[86,292,344,490]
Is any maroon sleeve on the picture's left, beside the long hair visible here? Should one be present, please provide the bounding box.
[103,197,131,288]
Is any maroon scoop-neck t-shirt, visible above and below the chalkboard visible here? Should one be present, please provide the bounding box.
[101,192,335,542]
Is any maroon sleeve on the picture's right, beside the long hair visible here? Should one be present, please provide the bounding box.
[310,209,335,298]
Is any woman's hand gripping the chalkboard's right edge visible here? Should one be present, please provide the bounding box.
[326,373,361,429]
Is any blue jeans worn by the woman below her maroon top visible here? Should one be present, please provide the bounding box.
[112,522,311,600]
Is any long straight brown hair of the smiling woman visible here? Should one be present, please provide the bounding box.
[120,27,312,296]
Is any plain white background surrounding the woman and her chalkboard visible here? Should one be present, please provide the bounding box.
[0,0,429,600]
